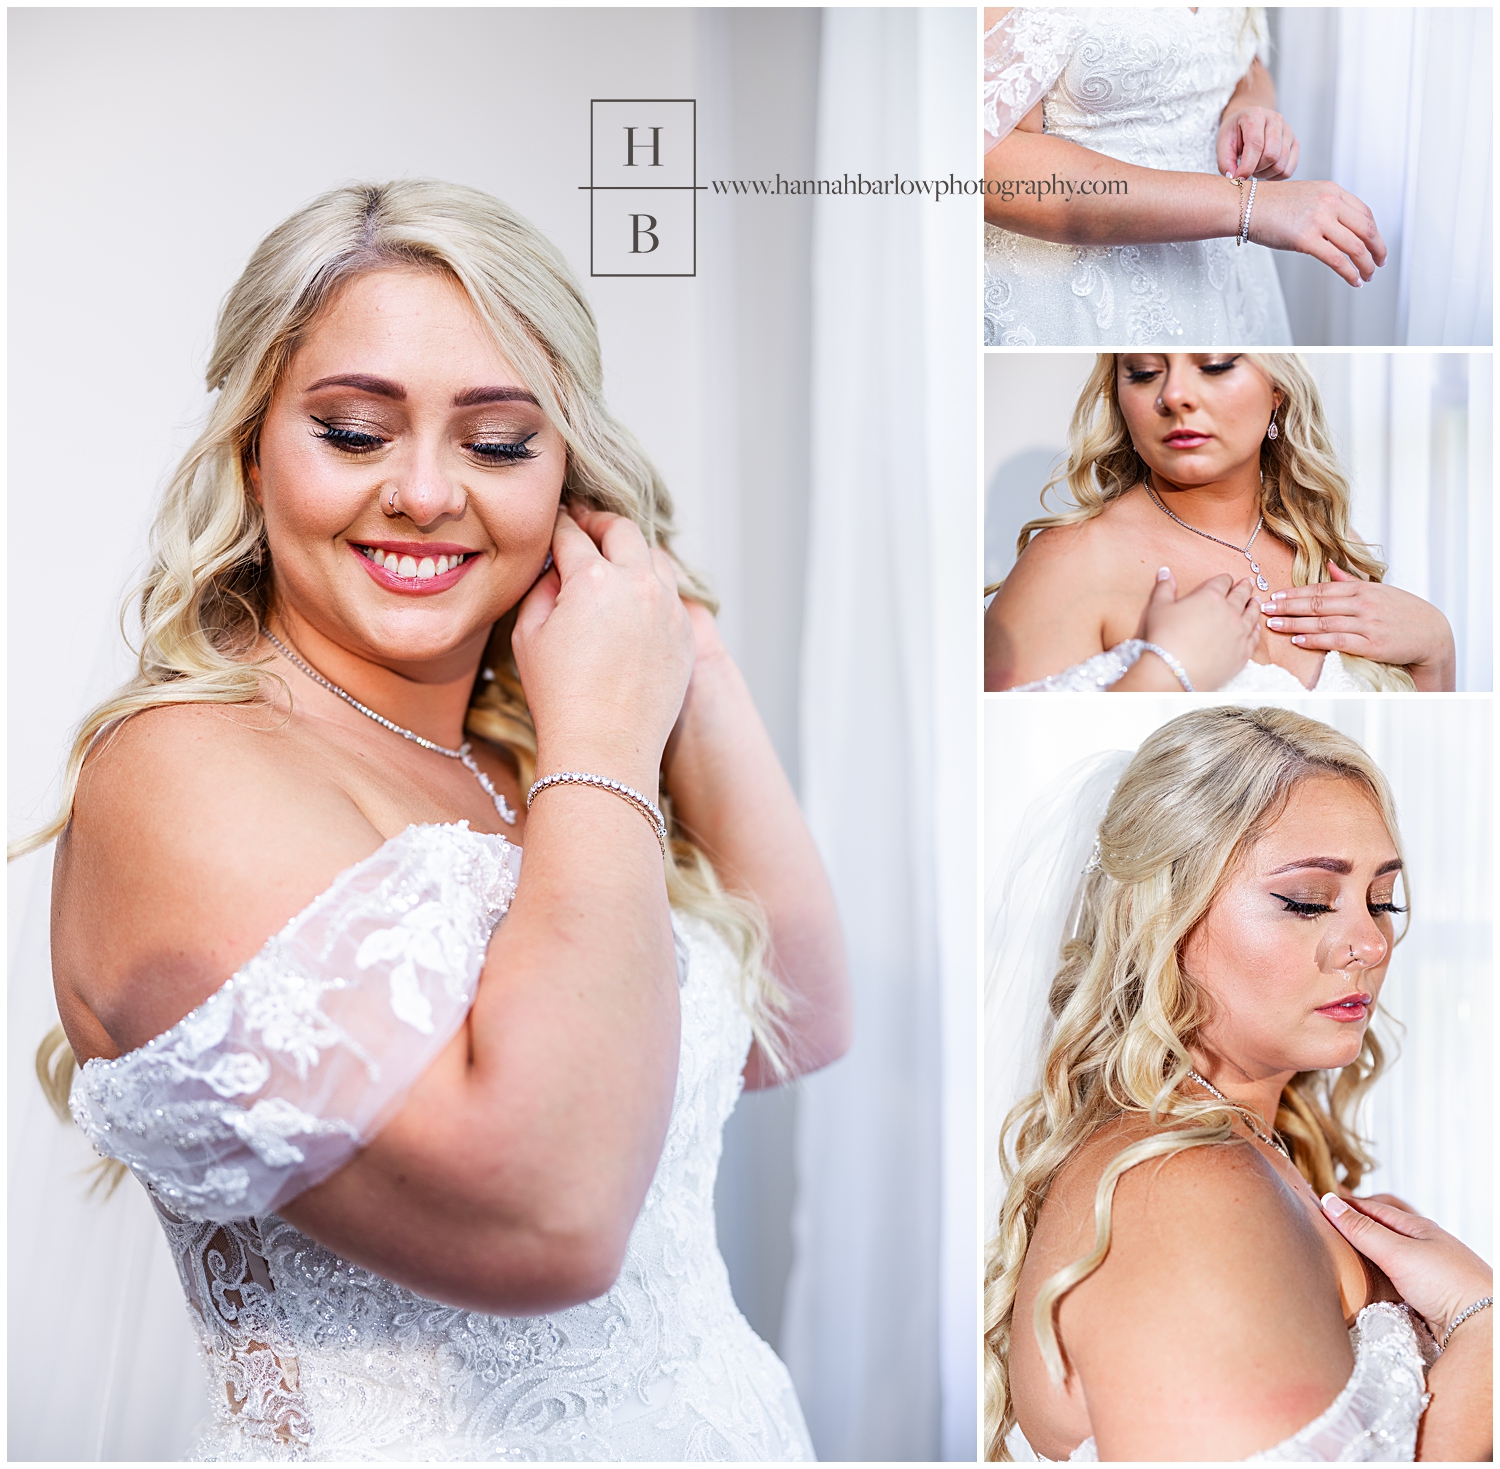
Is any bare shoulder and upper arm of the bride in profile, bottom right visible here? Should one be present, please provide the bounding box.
[1058,1119,1353,1460]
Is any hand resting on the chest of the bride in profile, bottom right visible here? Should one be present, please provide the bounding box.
[1323,1193,1494,1341]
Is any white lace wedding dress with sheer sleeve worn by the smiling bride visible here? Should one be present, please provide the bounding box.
[72,822,813,1460]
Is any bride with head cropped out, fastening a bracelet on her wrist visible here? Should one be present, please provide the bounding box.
[984,6,1386,347]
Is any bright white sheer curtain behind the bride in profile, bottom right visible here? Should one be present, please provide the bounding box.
[984,693,1494,1259]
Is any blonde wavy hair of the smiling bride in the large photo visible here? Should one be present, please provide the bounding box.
[20,179,788,1118]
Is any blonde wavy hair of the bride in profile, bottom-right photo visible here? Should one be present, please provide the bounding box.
[984,707,1404,1460]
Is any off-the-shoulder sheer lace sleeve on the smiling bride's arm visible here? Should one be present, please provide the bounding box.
[71,822,521,1221]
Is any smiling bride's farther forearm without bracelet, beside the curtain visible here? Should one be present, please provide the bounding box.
[663,653,852,1086]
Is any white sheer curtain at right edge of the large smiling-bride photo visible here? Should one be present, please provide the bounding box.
[782,11,978,1458]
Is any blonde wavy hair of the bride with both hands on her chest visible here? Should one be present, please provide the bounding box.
[1008,353,1416,693]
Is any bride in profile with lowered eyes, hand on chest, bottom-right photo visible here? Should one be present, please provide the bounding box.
[986,707,1491,1461]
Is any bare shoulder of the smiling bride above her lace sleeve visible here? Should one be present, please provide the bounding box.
[53,704,380,1053]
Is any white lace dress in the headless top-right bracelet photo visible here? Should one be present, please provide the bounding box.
[984,6,1292,348]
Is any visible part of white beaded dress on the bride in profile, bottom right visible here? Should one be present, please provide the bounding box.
[1017,1301,1433,1464]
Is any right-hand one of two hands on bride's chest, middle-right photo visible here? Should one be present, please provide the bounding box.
[1260,561,1455,690]
